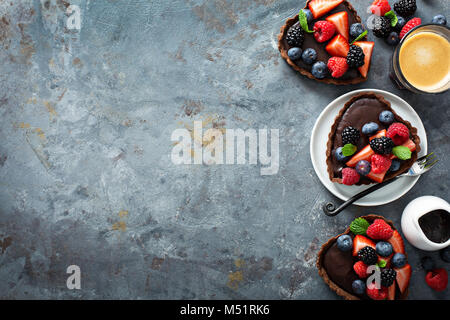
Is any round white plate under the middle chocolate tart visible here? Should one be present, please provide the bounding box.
[310,89,427,206]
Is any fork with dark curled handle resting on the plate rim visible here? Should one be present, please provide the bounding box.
[323,152,439,217]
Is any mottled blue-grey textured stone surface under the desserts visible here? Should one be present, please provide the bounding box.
[0,0,450,299]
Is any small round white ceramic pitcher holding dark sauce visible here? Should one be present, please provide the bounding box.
[402,196,450,251]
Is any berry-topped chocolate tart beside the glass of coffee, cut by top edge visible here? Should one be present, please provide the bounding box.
[278,0,374,85]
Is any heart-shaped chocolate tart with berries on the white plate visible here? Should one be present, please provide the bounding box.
[326,92,420,185]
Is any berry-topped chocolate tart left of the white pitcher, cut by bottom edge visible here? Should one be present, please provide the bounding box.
[316,215,412,300]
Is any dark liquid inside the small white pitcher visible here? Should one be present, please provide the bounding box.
[419,210,450,243]
